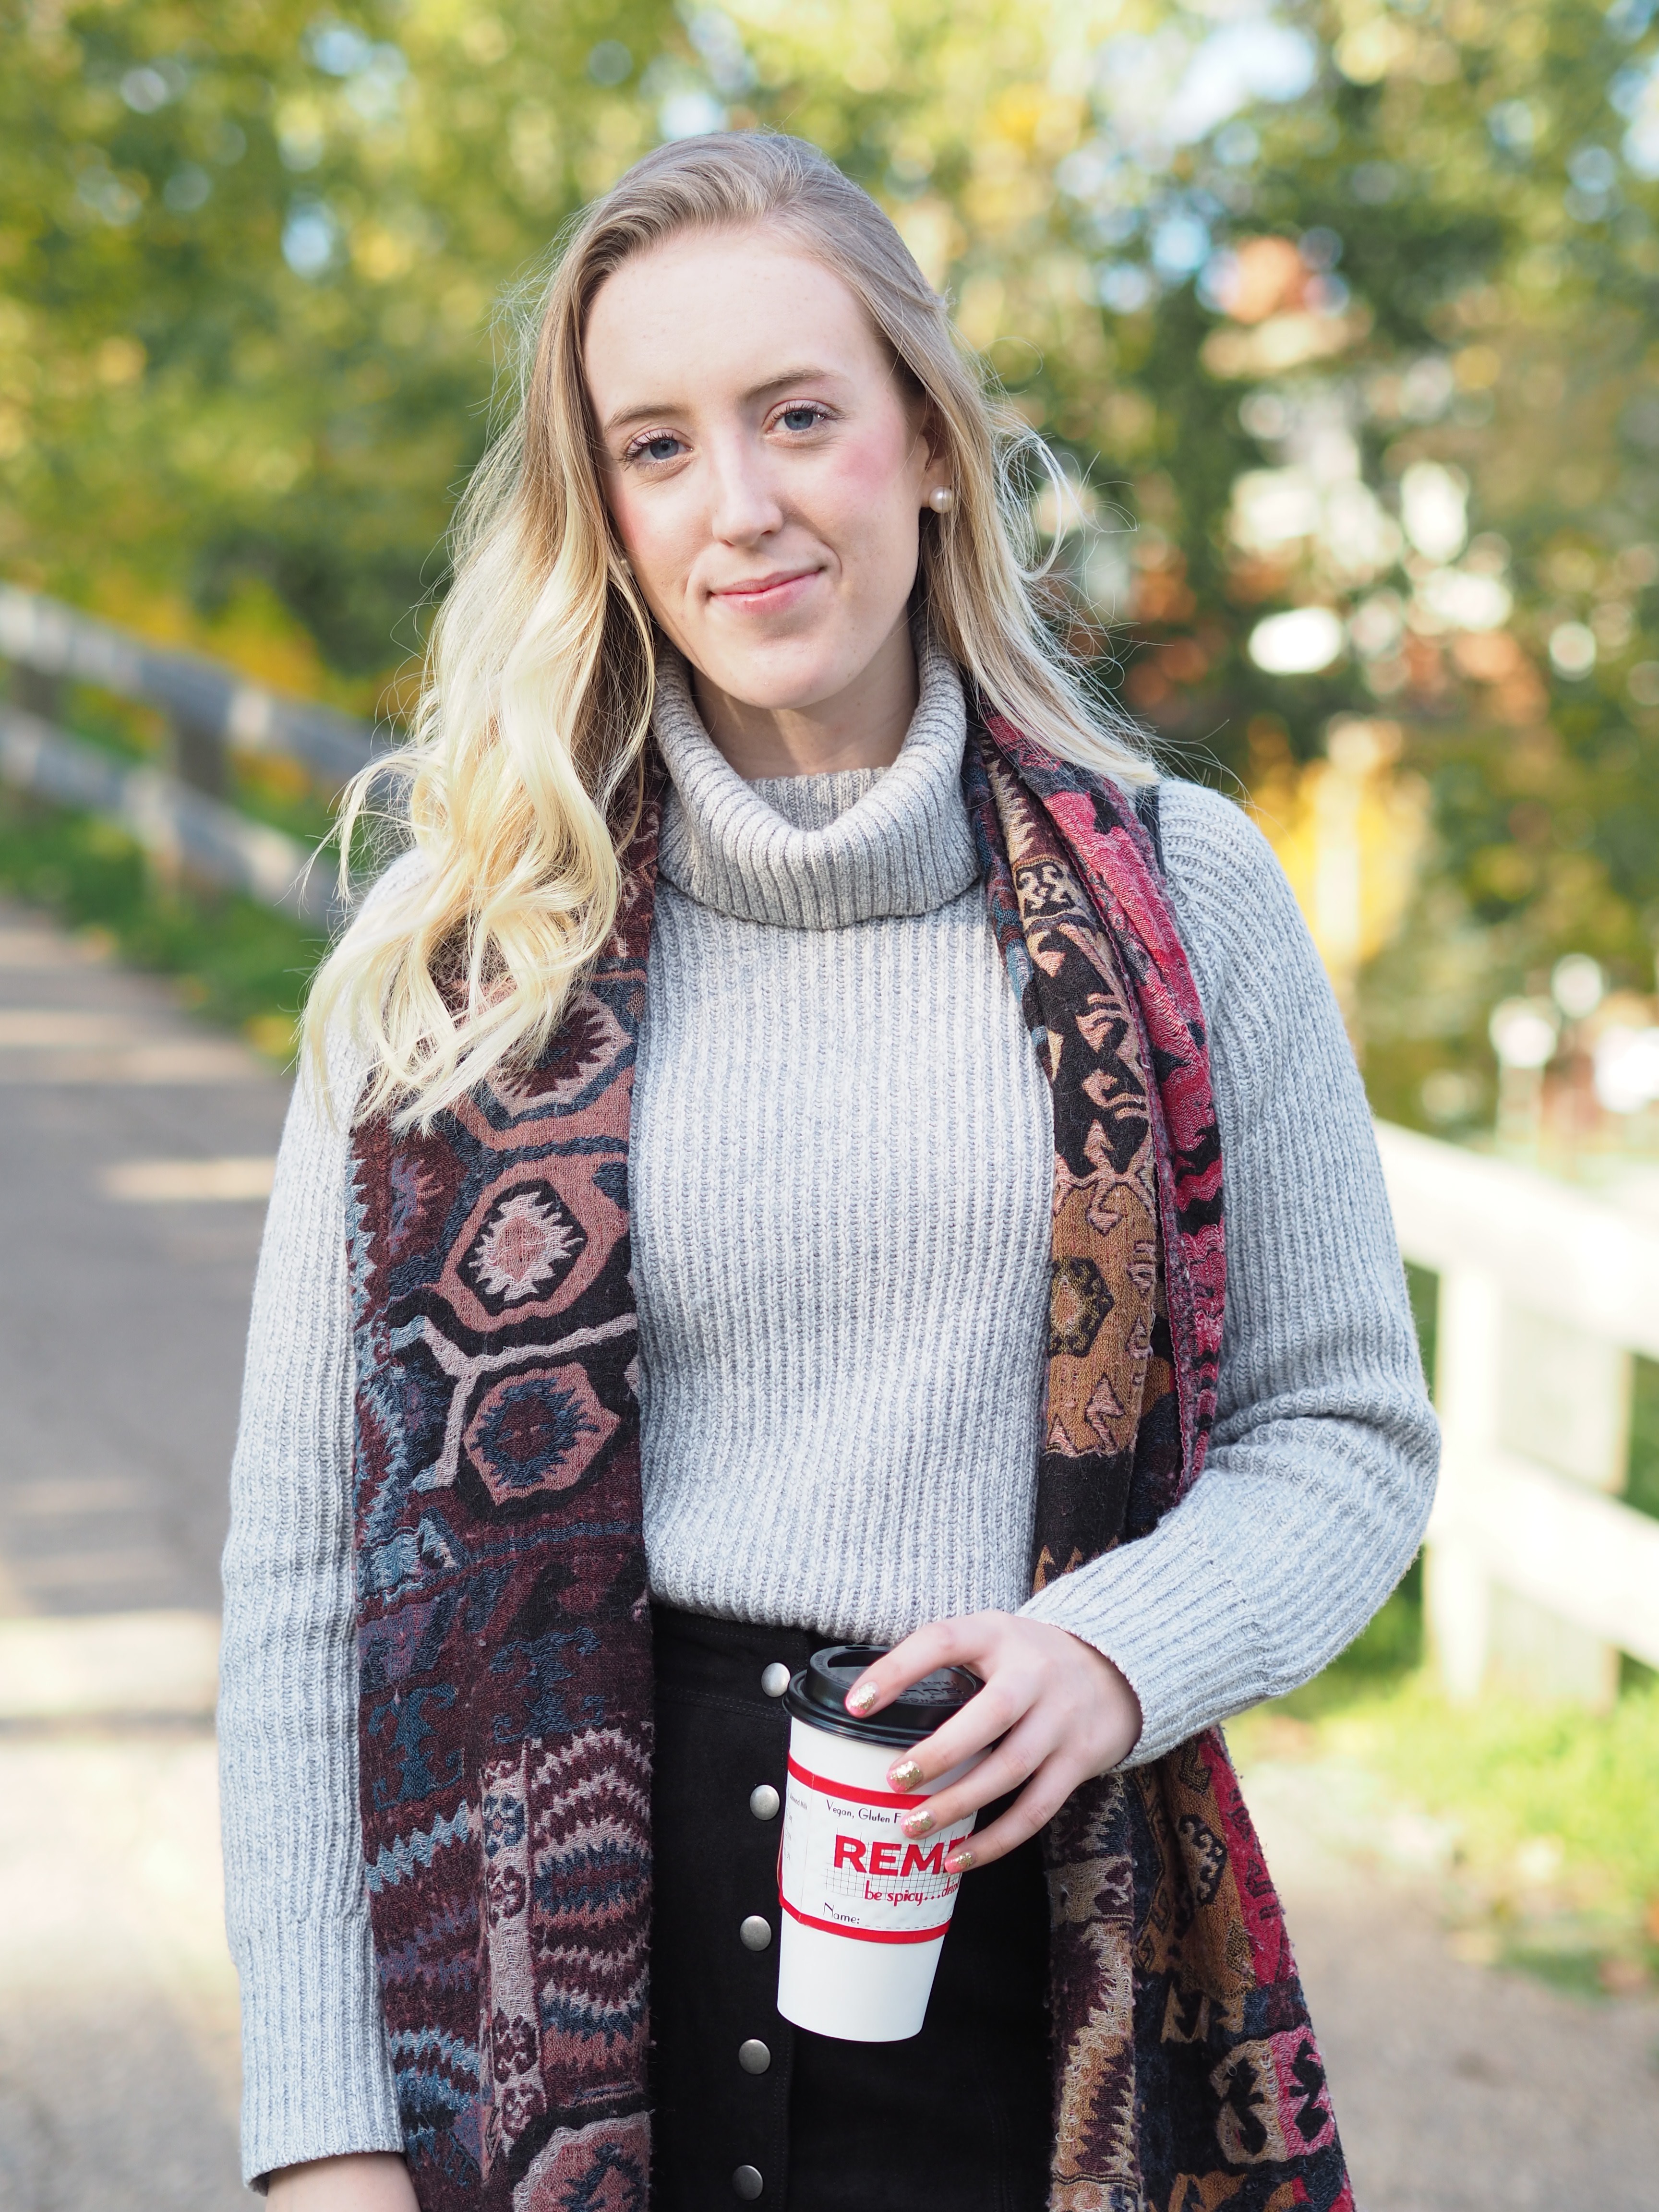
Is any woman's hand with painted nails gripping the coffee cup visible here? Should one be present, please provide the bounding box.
[847,1612,1142,1874]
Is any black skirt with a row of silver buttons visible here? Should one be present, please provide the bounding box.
[650,1606,1051,2212]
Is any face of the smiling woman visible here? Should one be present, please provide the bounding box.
[584,230,945,710]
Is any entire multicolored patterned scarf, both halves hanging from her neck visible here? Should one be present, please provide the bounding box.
[349,717,1351,2212]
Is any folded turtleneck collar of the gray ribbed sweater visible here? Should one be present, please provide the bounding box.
[652,637,980,929]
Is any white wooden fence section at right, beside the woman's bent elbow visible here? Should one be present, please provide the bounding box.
[1378,1126,1659,1707]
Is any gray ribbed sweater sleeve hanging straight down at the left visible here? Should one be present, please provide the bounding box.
[219,1022,403,2188]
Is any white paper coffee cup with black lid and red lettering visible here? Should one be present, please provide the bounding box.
[779,1644,985,2044]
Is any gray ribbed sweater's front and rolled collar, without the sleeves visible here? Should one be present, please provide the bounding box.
[633,632,1053,1644]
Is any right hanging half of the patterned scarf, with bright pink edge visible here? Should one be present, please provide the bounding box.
[964,717,1351,2212]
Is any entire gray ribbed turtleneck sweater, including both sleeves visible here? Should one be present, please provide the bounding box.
[219,657,1436,2175]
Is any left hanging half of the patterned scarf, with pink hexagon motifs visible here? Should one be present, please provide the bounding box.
[349,807,657,2212]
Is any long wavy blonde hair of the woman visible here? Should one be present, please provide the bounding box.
[305,132,1154,1128]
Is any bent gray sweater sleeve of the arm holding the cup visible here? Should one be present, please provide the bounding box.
[1022,783,1440,1765]
